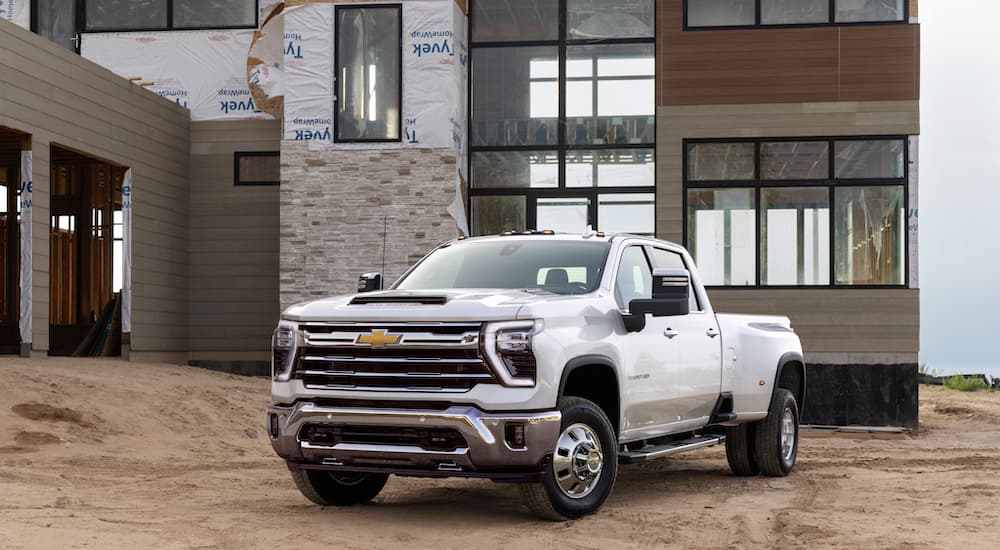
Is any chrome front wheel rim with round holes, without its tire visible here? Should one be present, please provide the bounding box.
[552,424,604,498]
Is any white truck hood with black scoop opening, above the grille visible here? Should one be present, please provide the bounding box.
[282,289,581,322]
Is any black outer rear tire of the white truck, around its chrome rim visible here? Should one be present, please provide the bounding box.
[753,388,799,477]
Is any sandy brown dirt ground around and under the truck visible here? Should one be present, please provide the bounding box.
[0,358,1000,550]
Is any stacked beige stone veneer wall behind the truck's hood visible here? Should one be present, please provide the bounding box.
[280,141,458,309]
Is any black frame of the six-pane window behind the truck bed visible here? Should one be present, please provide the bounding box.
[681,134,910,290]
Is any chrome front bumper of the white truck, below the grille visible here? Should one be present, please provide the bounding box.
[267,401,562,480]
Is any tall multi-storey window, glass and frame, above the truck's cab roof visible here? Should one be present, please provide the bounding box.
[469,0,656,235]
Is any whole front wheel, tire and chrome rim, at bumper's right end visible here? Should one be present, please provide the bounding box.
[520,397,618,521]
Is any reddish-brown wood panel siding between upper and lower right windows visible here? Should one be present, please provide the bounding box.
[657,0,920,105]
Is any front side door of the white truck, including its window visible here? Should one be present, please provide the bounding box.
[614,244,683,439]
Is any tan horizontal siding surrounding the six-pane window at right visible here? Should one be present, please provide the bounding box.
[656,101,920,358]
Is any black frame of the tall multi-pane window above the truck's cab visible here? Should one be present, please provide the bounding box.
[466,0,660,237]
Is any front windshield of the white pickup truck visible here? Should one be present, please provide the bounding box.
[395,239,611,294]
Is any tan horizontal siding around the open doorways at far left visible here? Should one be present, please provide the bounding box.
[0,21,191,352]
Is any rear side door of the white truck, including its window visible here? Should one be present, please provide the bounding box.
[647,246,722,427]
